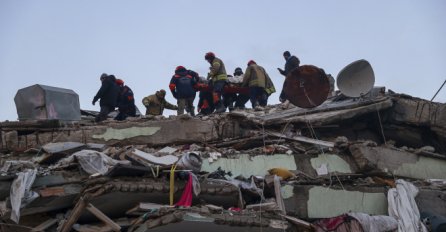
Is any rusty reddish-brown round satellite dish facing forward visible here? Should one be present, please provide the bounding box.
[283,65,330,108]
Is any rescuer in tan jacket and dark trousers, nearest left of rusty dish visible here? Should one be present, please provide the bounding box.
[242,60,269,110]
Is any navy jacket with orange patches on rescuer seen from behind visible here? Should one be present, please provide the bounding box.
[169,70,197,99]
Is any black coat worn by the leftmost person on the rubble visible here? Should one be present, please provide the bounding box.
[93,77,119,109]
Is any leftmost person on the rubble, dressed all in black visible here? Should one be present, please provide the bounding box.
[92,73,119,122]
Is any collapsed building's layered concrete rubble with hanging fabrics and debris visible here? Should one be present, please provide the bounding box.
[0,89,446,232]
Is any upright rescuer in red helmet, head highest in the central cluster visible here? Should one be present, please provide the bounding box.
[204,52,228,113]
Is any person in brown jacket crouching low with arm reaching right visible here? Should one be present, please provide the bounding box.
[142,89,178,116]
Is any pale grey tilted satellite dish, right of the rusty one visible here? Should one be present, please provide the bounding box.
[336,60,375,97]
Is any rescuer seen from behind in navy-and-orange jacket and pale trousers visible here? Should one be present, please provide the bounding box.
[169,66,197,116]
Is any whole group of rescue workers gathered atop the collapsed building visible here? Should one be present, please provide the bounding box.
[93,51,300,122]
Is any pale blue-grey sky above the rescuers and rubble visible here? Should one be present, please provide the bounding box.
[0,0,446,121]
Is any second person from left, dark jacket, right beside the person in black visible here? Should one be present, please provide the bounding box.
[115,79,136,121]
